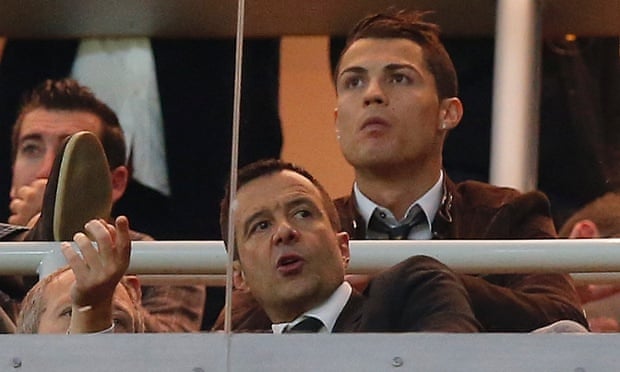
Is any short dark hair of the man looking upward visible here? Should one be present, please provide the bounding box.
[334,8,458,99]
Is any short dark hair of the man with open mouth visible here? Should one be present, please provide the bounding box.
[220,159,341,258]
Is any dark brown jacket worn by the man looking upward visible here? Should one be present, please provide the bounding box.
[336,177,588,332]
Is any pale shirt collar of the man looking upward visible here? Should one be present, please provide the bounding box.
[353,170,444,231]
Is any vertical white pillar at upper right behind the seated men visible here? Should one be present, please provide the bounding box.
[489,0,541,191]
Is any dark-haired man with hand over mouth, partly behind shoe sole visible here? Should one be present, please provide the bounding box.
[3,79,205,332]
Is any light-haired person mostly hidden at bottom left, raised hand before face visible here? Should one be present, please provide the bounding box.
[17,216,145,334]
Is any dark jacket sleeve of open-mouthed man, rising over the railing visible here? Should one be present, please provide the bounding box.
[361,256,480,332]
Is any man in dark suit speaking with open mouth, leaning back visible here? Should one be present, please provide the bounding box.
[220,160,479,333]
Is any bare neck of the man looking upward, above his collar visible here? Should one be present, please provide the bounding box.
[355,161,441,220]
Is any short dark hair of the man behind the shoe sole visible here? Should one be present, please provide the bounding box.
[11,78,127,169]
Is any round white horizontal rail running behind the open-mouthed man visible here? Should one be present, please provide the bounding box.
[0,239,620,280]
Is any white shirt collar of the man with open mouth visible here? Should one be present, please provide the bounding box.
[271,281,353,333]
